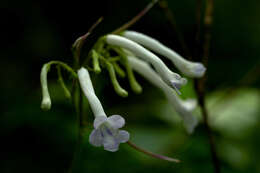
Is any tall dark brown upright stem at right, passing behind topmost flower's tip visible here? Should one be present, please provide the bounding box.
[195,0,220,173]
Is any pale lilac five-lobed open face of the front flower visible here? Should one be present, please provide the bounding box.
[89,115,130,152]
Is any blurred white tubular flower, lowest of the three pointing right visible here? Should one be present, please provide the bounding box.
[128,56,198,133]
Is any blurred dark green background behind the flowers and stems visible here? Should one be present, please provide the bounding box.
[0,0,260,173]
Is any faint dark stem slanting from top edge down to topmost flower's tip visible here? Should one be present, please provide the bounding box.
[159,0,191,59]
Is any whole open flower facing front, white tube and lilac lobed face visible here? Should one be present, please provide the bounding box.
[78,67,130,152]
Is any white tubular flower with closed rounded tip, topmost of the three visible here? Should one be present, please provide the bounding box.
[122,31,206,78]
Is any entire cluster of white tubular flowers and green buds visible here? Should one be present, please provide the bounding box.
[41,31,206,152]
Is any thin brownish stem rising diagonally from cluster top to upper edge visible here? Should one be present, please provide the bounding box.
[112,0,159,34]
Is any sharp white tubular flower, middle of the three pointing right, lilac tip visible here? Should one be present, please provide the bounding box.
[106,34,187,92]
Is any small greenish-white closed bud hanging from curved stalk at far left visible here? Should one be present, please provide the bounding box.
[40,64,51,110]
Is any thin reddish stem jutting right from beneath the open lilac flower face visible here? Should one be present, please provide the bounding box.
[127,141,180,163]
